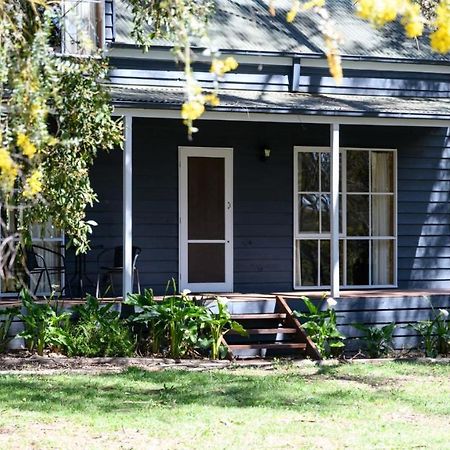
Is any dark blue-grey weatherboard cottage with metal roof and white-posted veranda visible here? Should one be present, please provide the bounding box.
[74,0,450,348]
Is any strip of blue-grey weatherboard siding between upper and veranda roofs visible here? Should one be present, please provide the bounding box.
[109,56,450,98]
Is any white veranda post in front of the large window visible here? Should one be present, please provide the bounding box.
[330,123,340,298]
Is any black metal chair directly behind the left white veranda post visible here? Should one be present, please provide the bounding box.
[95,245,142,298]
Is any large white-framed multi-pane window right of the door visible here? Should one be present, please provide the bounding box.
[294,147,397,288]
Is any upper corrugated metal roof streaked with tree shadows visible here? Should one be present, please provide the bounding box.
[115,0,450,61]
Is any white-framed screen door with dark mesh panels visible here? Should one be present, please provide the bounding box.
[179,147,233,292]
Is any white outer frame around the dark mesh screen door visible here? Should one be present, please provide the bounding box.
[178,146,234,292]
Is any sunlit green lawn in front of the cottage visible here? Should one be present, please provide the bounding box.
[0,362,450,450]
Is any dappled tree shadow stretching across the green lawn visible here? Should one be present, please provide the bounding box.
[0,367,446,414]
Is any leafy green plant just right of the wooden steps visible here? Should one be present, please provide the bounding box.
[294,297,345,358]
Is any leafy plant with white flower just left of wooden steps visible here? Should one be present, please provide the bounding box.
[205,298,248,359]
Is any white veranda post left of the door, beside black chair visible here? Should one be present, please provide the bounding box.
[122,115,133,299]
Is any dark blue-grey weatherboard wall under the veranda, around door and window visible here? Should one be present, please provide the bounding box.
[68,119,450,293]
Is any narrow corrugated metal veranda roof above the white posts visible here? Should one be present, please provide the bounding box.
[109,85,450,120]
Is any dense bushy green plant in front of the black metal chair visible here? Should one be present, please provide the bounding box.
[67,295,135,357]
